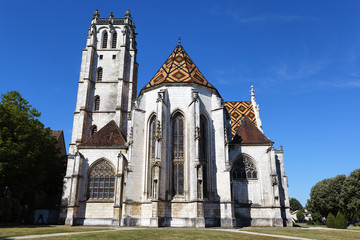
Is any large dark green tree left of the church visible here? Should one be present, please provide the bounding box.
[0,91,63,210]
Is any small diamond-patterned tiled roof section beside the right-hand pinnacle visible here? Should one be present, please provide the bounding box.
[225,102,256,136]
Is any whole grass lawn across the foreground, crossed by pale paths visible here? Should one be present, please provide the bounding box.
[0,225,360,240]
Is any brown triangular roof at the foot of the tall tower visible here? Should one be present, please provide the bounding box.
[80,120,126,147]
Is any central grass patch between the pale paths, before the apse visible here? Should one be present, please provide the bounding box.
[42,229,279,240]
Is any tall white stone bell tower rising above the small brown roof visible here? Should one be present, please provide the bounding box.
[69,9,138,155]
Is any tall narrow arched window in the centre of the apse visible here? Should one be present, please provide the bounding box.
[172,113,184,196]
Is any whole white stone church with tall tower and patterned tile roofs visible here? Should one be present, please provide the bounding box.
[60,10,292,228]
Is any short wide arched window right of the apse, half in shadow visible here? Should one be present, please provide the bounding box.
[232,154,257,180]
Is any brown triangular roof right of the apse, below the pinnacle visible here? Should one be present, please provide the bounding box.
[231,115,273,145]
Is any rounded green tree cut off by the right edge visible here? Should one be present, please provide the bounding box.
[340,168,360,222]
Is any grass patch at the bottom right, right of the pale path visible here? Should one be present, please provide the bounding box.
[241,228,360,240]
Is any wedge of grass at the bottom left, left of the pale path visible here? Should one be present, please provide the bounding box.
[0,225,110,238]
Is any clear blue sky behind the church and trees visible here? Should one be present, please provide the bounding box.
[0,0,360,204]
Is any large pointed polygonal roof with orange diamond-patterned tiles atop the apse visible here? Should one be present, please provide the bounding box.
[143,44,215,90]
